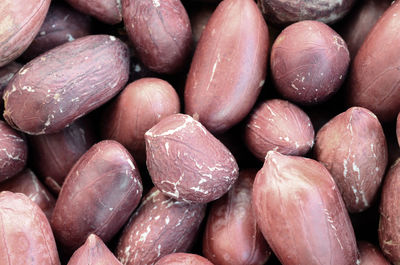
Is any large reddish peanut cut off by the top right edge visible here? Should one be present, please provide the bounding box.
[347,1,400,122]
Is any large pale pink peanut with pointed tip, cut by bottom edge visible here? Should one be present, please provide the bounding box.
[252,151,358,265]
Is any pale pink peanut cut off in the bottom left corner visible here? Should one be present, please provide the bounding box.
[0,191,60,265]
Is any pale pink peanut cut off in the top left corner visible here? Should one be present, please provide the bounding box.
[0,0,50,67]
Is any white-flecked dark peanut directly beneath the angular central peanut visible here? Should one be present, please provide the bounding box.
[116,188,206,265]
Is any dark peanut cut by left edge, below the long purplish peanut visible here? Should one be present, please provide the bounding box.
[0,120,28,182]
